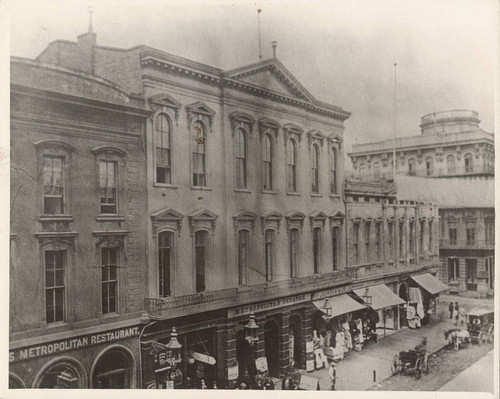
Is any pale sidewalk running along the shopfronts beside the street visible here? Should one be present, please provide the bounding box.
[296,296,485,391]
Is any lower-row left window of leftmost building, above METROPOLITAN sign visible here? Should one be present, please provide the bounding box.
[45,251,66,323]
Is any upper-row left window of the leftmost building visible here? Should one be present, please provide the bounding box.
[43,155,64,215]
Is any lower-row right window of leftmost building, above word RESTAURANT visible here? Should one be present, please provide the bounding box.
[101,248,119,314]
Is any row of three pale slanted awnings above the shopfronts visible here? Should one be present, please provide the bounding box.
[313,273,448,317]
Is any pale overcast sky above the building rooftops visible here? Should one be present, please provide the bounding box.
[6,0,498,159]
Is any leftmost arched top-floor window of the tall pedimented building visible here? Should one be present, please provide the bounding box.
[155,114,172,184]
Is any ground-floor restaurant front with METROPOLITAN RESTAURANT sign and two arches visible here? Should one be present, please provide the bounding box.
[9,324,140,389]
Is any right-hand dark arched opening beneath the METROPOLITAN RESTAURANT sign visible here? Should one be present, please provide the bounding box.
[92,348,134,389]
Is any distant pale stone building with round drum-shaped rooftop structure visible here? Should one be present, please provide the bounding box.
[349,110,495,296]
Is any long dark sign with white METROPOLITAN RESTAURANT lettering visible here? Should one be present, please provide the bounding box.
[9,327,139,363]
